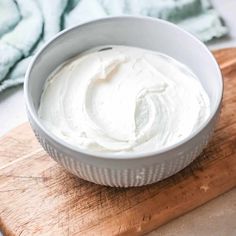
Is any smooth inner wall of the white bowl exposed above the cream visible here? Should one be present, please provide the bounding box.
[25,17,223,151]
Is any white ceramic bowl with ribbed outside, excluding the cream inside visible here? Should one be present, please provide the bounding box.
[24,16,223,187]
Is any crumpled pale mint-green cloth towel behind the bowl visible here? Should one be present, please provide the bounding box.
[0,0,227,92]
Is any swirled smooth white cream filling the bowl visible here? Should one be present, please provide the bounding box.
[38,46,210,152]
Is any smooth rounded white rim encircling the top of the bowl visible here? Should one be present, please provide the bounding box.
[24,16,224,160]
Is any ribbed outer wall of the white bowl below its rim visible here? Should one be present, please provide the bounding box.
[29,111,218,187]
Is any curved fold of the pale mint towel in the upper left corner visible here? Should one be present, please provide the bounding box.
[0,0,43,85]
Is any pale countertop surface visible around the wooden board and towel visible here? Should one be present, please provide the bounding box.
[0,0,236,236]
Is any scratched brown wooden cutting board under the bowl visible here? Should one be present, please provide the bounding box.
[0,49,236,236]
